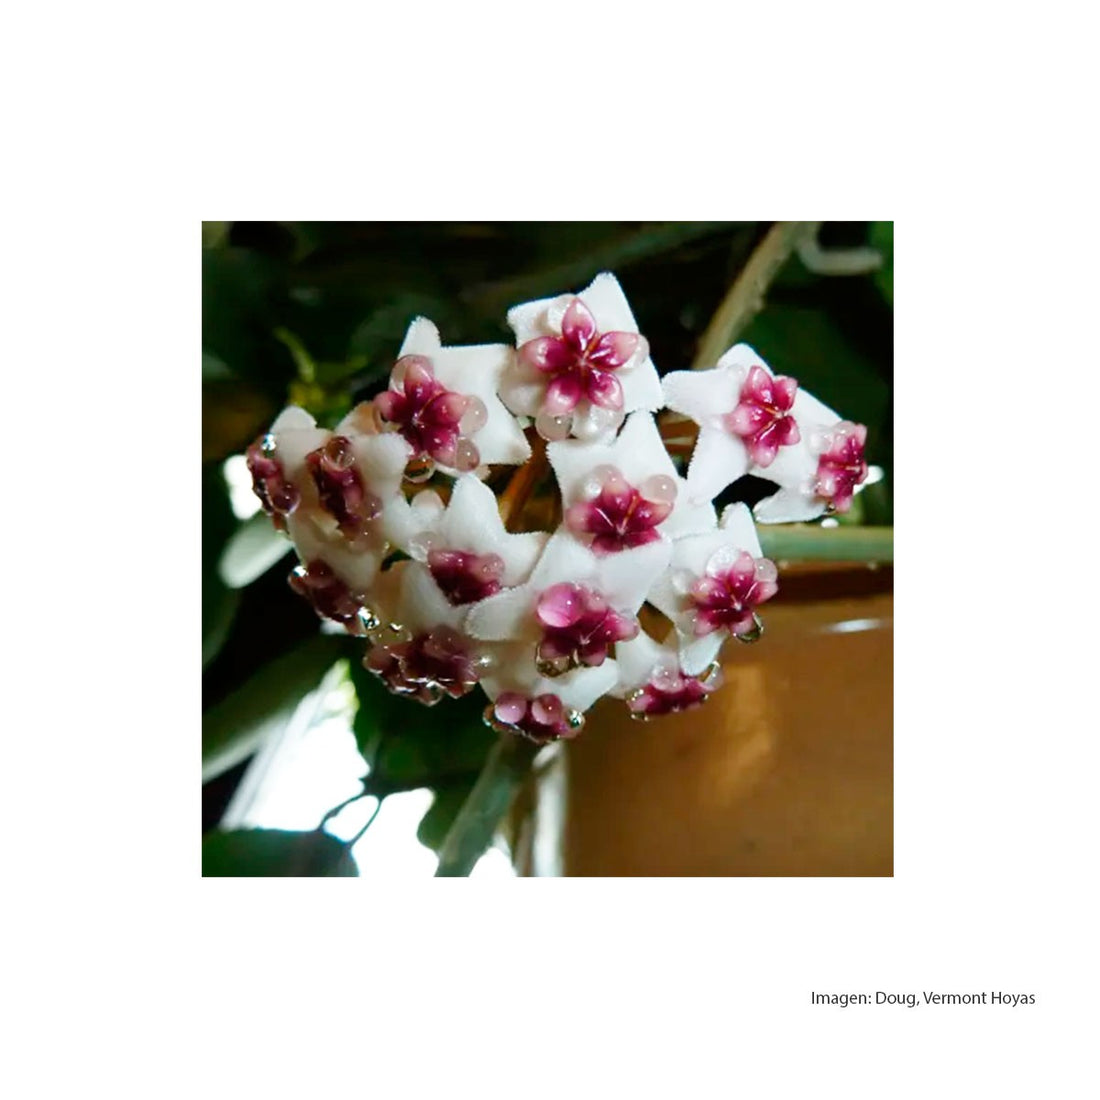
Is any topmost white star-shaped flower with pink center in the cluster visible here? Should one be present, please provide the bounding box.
[501,273,661,440]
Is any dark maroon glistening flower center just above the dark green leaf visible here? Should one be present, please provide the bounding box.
[363,626,480,706]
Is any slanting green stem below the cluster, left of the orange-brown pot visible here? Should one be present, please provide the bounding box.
[436,734,540,878]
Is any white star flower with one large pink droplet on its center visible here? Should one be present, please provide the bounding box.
[465,529,671,677]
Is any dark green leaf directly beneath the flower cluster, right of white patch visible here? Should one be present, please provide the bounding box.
[351,659,496,796]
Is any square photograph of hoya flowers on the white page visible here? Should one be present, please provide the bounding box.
[201,221,893,879]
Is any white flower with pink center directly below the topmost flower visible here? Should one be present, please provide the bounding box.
[547,413,716,554]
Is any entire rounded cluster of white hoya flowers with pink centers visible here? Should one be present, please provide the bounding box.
[248,274,867,743]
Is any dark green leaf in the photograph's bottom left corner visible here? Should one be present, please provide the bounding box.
[202,828,359,878]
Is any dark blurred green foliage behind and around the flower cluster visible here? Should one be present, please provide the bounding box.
[202,222,893,875]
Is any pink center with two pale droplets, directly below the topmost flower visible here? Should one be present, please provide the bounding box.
[565,466,677,554]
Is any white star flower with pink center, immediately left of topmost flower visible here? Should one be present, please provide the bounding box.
[372,317,531,480]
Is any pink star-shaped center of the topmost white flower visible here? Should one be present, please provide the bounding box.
[519,298,644,417]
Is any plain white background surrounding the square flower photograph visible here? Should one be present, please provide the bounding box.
[0,0,1100,1100]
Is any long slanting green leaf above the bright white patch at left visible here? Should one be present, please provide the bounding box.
[202,634,349,783]
